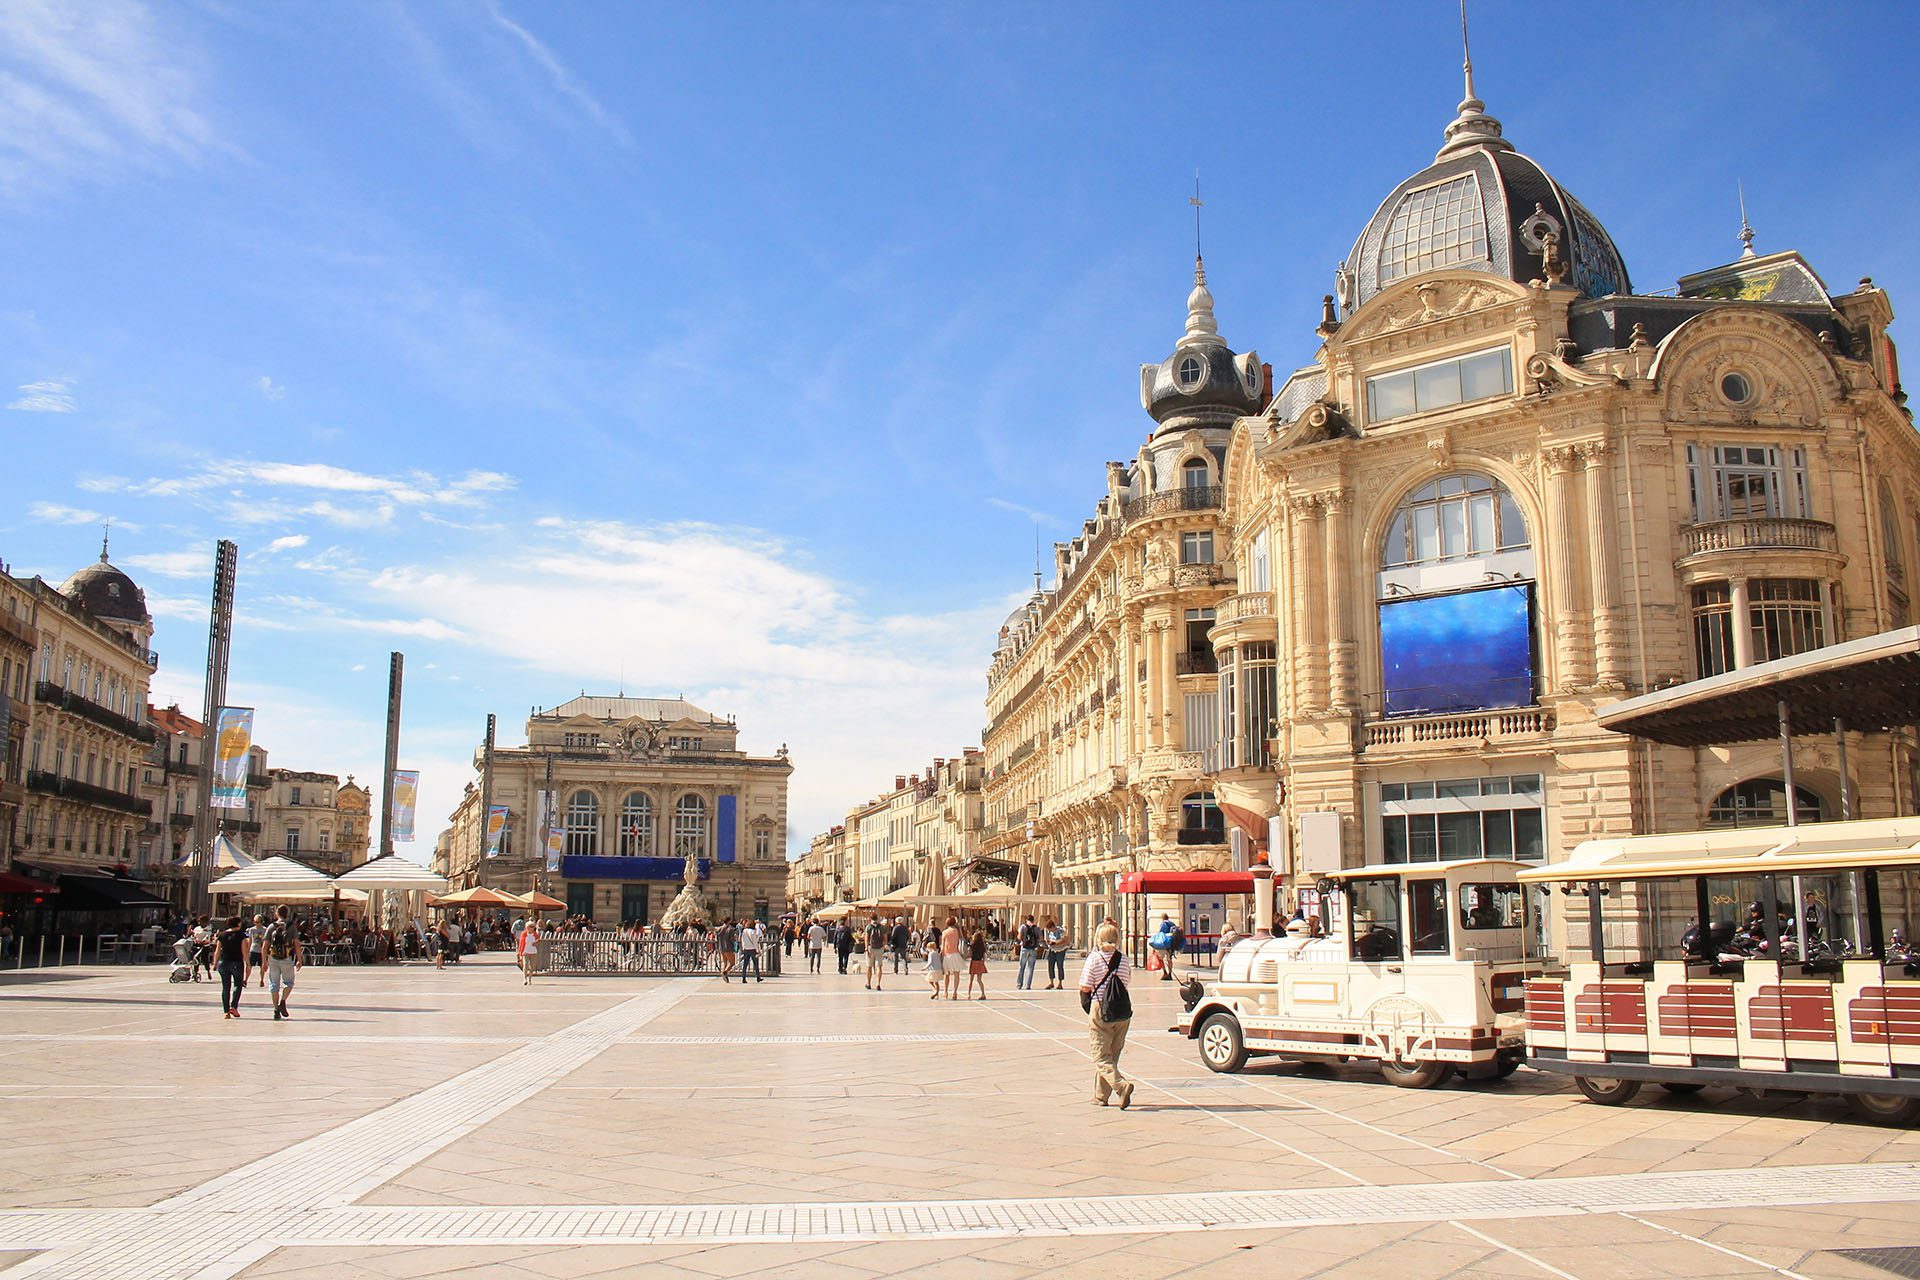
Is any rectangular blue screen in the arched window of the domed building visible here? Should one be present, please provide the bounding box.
[1380,583,1534,716]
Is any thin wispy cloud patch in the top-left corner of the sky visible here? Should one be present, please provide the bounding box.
[0,0,217,194]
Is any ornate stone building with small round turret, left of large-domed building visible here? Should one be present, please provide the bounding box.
[983,261,1269,936]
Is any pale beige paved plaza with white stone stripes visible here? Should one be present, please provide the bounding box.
[0,956,1920,1280]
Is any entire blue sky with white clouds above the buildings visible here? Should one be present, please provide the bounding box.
[0,0,1920,852]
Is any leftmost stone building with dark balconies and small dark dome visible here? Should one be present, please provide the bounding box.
[8,545,157,871]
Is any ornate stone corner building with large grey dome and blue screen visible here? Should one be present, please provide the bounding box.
[1210,69,1920,948]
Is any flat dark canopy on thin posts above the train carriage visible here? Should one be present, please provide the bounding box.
[1597,628,1920,825]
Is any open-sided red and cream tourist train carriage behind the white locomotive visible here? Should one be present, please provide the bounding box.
[1519,818,1920,1125]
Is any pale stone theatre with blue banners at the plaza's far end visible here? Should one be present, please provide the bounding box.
[438,695,793,927]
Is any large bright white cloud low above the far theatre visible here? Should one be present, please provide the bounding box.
[341,518,1006,839]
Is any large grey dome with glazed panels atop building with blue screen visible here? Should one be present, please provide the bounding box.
[1334,61,1632,313]
